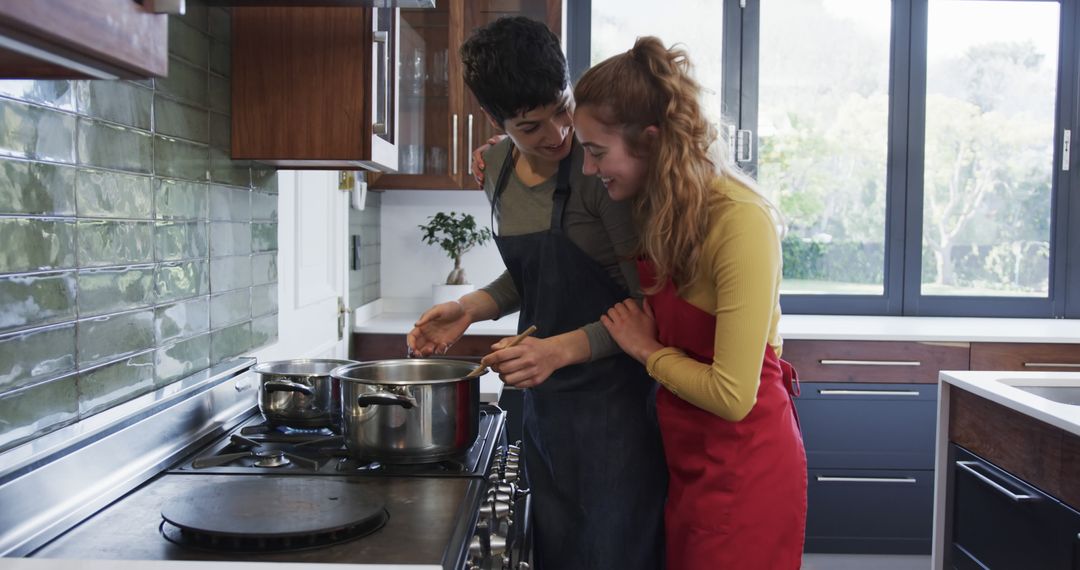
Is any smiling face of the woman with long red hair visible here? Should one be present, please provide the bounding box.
[573,106,656,201]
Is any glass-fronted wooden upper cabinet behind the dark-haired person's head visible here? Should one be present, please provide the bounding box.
[369,0,563,190]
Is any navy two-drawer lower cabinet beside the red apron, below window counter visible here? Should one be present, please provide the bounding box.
[795,382,937,554]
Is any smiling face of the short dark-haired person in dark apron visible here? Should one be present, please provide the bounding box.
[502,87,573,162]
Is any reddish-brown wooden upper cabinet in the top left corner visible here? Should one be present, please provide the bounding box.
[0,0,168,79]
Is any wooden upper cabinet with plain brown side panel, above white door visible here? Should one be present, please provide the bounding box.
[232,6,399,169]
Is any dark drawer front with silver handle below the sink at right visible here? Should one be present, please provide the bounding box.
[945,444,1080,570]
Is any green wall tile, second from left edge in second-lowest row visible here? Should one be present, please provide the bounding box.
[76,309,153,368]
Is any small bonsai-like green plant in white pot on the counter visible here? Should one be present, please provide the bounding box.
[419,212,491,304]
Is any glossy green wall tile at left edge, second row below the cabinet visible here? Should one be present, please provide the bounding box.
[0,99,76,163]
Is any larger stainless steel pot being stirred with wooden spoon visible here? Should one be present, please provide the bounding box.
[332,358,480,463]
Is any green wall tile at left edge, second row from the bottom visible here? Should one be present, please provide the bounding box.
[0,323,76,388]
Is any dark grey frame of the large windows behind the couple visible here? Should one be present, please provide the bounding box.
[567,0,1080,318]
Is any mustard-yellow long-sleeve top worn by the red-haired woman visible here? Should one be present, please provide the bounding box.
[646,178,783,421]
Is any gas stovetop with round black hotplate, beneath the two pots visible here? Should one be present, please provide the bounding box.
[30,406,516,569]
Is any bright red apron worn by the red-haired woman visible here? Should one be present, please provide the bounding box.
[638,261,807,570]
